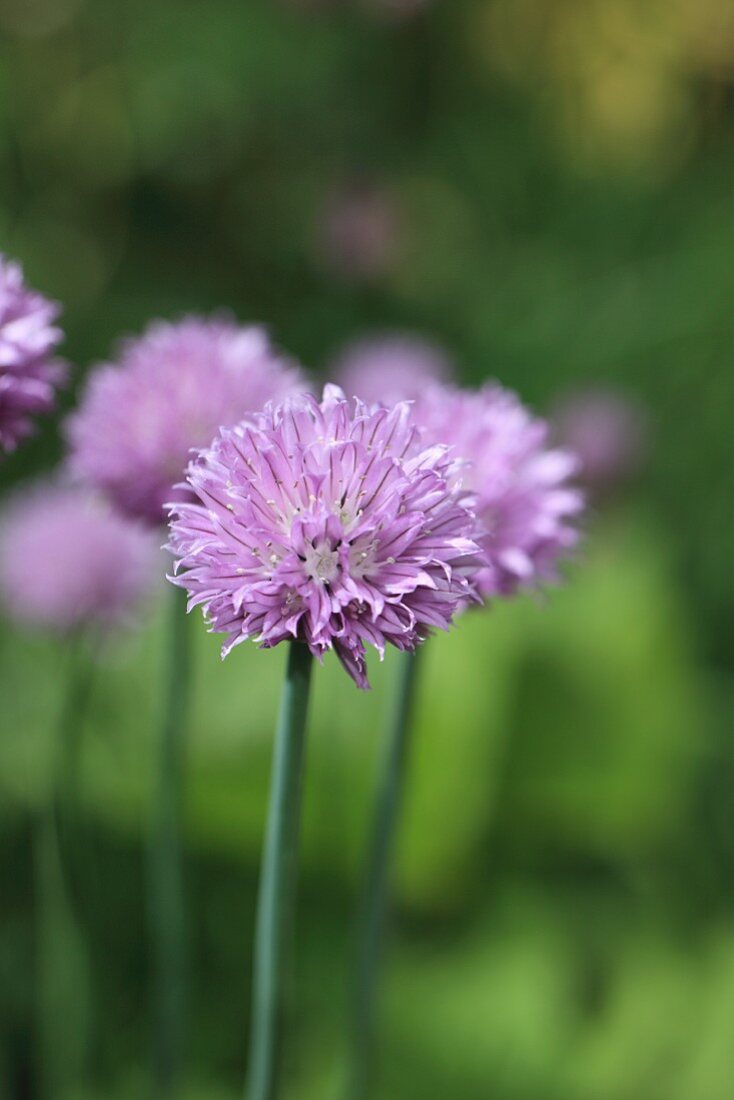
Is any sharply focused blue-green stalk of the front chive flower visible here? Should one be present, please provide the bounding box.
[247,641,313,1100]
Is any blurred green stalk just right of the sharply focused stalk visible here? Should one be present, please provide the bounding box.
[346,652,418,1100]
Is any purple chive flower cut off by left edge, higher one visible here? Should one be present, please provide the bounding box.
[0,254,66,453]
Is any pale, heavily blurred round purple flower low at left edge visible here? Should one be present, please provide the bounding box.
[0,485,163,631]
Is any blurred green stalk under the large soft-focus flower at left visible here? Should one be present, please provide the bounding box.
[149,589,190,1100]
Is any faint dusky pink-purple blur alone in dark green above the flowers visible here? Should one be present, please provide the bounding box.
[318,183,401,282]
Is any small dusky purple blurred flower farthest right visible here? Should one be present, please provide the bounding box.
[552,388,648,491]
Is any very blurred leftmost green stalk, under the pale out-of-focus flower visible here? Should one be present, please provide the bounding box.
[36,636,92,1096]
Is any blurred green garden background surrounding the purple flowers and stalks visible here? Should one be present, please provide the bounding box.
[0,0,734,1100]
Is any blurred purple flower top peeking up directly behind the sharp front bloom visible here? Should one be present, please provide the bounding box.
[332,333,453,406]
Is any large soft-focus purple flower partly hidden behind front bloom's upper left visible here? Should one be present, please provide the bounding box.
[67,317,304,524]
